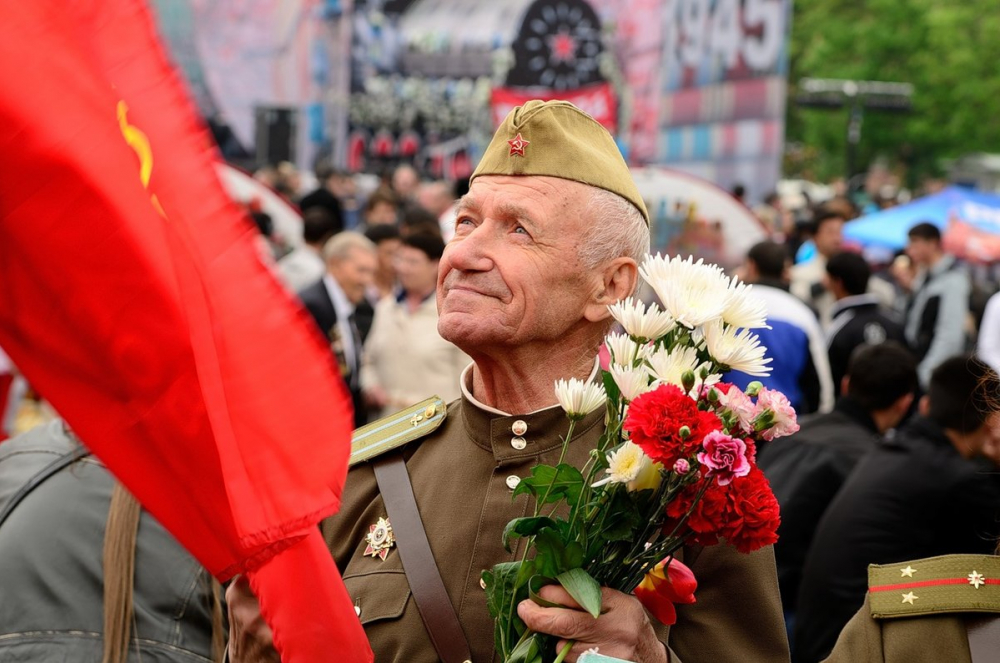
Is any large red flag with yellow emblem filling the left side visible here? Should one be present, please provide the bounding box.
[0,0,371,663]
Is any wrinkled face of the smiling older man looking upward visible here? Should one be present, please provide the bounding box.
[437,175,601,353]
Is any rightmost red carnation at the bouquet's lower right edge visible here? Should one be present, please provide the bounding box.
[722,467,781,553]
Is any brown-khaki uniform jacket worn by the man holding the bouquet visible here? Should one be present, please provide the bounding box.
[322,397,789,663]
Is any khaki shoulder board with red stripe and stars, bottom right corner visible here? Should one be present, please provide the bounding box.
[868,555,1000,619]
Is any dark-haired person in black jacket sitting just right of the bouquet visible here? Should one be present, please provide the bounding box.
[758,341,917,623]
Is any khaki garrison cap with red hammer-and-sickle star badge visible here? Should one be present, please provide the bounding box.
[470,100,649,225]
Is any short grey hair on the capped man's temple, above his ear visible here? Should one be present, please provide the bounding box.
[580,187,649,269]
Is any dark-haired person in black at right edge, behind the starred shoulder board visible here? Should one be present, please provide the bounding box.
[793,356,1000,663]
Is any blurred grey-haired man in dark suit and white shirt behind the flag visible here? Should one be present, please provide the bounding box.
[299,231,377,428]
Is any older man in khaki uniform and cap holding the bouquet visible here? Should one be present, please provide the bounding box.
[228,101,788,663]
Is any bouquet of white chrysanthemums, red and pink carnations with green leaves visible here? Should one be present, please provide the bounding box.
[483,256,798,663]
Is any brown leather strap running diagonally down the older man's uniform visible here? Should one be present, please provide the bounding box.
[374,453,472,663]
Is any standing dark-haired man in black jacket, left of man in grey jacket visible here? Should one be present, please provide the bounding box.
[825,252,906,396]
